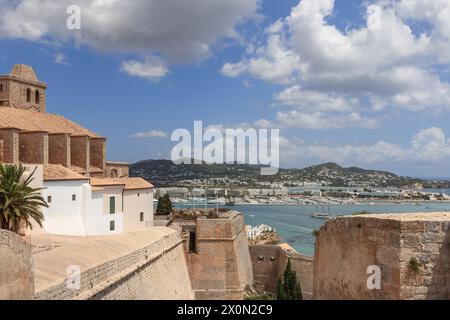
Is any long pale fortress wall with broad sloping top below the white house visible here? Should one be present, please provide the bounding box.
[34,228,194,300]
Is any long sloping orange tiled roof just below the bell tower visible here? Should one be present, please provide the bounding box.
[0,107,101,138]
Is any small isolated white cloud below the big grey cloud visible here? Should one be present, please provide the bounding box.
[121,57,169,80]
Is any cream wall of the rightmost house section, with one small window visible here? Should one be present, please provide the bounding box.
[123,189,153,232]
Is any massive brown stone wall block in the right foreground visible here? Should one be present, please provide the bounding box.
[314,213,450,299]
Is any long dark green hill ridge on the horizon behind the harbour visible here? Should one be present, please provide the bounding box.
[130,160,425,187]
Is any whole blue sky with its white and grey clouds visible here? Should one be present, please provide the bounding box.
[0,0,450,177]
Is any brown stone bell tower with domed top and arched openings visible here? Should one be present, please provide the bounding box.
[0,64,47,112]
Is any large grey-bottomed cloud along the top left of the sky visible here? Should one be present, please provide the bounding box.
[0,0,259,63]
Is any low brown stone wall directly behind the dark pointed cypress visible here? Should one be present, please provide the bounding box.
[250,244,314,300]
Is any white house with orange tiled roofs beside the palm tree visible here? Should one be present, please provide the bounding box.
[42,165,154,236]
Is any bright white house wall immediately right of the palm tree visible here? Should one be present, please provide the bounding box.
[42,180,90,236]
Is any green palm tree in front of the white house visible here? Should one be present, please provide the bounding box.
[0,165,48,234]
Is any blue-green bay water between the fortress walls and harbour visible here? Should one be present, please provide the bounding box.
[178,202,450,255]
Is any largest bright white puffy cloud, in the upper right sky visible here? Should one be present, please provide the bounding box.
[222,0,450,128]
